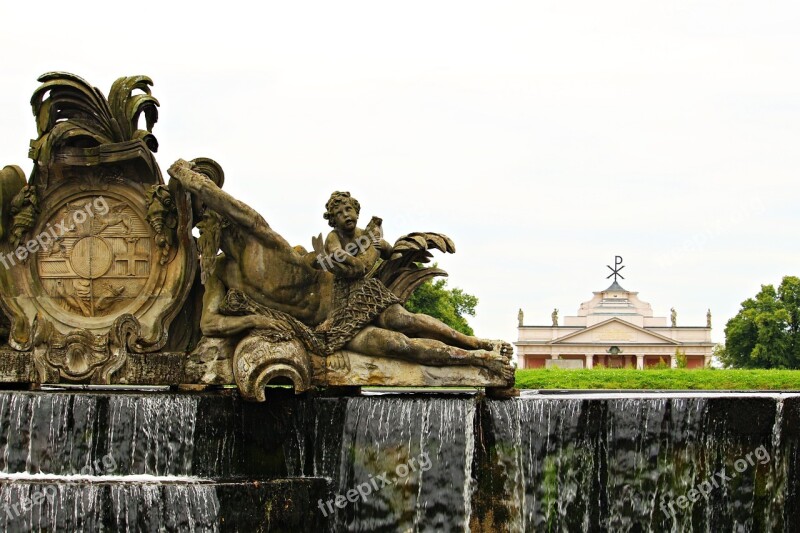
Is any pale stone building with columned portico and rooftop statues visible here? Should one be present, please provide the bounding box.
[515,281,714,368]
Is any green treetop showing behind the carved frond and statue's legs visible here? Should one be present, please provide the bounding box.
[406,278,478,335]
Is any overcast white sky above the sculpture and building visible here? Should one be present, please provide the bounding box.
[0,0,800,341]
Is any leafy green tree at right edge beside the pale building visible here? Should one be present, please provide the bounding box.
[720,276,800,368]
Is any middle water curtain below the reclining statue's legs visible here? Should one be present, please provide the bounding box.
[334,397,475,531]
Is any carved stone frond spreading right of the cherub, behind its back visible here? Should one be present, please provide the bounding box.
[373,232,456,302]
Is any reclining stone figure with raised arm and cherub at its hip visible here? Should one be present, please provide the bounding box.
[169,160,514,380]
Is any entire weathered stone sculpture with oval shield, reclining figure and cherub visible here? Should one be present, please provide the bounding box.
[0,73,513,400]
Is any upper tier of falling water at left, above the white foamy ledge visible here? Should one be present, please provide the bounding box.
[0,393,198,475]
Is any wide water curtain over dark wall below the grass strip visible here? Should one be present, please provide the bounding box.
[478,395,796,532]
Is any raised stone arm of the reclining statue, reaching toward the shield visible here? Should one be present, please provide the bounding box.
[167,159,291,248]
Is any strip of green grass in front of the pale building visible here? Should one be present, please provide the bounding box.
[516,368,800,390]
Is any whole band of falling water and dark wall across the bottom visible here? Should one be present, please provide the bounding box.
[0,391,800,532]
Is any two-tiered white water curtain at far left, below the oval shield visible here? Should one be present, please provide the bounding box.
[0,393,219,531]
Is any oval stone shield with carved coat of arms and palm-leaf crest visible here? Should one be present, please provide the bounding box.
[0,72,196,384]
